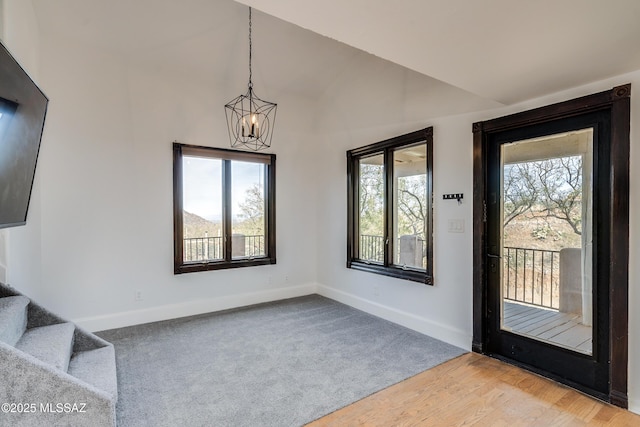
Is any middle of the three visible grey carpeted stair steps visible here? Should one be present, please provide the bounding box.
[16,323,75,372]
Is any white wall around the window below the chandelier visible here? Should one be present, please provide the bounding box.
[12,32,317,330]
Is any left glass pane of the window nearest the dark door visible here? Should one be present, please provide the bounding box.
[358,154,385,263]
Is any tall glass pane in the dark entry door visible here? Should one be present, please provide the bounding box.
[501,129,594,354]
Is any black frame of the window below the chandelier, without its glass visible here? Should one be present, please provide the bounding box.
[173,142,276,274]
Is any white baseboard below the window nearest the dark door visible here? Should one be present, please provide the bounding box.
[317,284,471,350]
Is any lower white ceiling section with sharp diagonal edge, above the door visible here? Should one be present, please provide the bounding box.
[240,0,640,104]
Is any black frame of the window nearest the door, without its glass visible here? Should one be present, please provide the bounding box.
[347,127,433,285]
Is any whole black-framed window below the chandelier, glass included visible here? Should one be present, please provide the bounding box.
[173,143,276,274]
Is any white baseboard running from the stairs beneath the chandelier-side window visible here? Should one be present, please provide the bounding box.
[74,283,316,332]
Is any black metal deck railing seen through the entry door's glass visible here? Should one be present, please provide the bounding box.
[502,247,560,310]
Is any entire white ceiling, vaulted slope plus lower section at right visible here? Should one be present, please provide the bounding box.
[32,0,640,117]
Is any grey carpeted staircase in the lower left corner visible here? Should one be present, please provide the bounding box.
[0,284,118,427]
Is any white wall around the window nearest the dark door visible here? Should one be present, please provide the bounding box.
[318,122,472,348]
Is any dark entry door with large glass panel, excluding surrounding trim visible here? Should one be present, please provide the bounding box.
[486,112,611,395]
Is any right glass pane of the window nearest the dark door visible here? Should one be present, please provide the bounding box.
[393,144,427,268]
